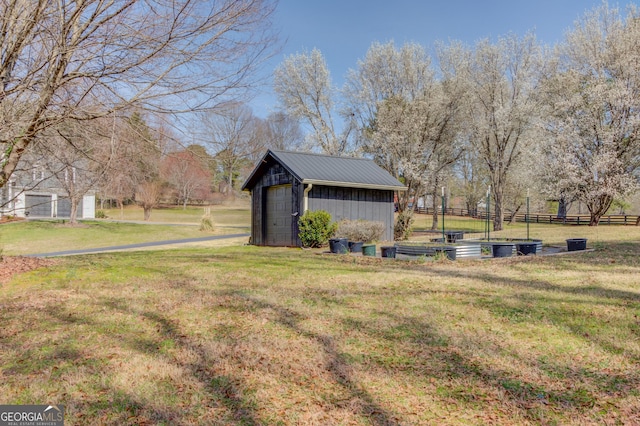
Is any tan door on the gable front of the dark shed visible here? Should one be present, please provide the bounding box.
[265,185,291,246]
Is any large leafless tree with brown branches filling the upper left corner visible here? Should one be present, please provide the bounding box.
[0,0,275,187]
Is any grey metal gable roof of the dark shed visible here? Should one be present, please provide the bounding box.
[242,150,406,191]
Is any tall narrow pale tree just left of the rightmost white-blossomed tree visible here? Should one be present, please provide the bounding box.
[456,34,543,231]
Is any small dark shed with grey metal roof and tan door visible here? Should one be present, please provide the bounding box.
[242,150,406,246]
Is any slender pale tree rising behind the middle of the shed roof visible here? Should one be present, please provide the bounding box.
[274,49,350,155]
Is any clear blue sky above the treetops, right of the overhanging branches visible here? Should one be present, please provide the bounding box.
[251,0,628,117]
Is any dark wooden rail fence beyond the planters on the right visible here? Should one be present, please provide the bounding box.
[415,208,640,225]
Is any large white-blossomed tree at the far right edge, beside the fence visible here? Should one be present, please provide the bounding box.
[544,3,640,225]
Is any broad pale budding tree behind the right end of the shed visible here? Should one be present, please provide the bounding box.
[345,43,464,238]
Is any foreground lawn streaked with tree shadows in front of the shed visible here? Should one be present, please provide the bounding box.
[0,227,640,425]
